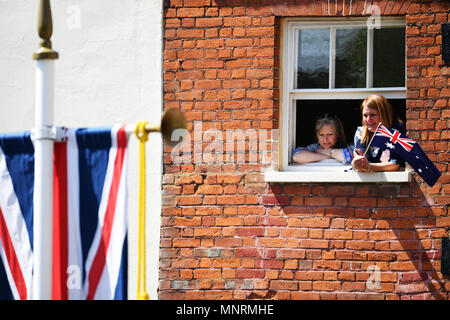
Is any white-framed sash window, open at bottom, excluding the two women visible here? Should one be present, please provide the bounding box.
[266,17,409,182]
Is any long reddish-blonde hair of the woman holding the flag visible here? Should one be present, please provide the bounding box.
[360,94,398,145]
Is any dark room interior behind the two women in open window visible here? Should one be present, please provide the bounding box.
[295,99,406,147]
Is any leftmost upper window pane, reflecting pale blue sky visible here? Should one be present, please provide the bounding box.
[297,29,330,88]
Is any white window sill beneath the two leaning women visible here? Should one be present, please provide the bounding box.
[264,166,411,183]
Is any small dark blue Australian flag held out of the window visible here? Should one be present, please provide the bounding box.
[372,125,441,187]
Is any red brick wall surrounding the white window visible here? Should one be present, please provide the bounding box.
[159,0,450,299]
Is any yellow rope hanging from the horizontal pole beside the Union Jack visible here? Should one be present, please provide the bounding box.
[134,121,149,300]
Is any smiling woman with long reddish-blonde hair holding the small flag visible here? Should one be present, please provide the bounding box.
[352,95,406,172]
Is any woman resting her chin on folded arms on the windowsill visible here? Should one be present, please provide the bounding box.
[292,115,352,164]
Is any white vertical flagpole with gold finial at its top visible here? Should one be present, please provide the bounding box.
[31,0,58,300]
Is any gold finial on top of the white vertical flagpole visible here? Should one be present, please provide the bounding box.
[33,0,58,60]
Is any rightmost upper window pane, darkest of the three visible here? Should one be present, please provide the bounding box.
[373,28,405,87]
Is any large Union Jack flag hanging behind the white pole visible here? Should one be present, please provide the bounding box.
[0,126,127,300]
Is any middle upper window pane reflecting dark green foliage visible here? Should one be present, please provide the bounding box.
[335,29,367,88]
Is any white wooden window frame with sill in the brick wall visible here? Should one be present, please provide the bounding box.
[265,17,410,182]
